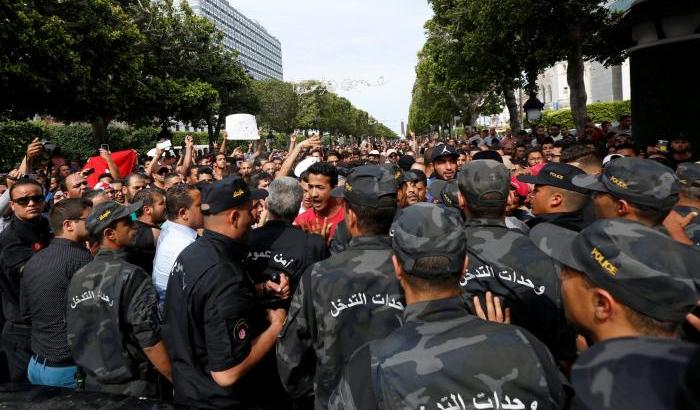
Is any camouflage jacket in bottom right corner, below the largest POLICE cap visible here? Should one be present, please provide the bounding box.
[571,337,698,410]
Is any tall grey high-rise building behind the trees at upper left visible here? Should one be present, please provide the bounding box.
[187,0,282,80]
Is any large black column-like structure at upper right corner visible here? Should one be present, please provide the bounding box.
[617,0,700,147]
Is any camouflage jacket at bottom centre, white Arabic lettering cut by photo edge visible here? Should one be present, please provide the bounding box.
[329,298,570,410]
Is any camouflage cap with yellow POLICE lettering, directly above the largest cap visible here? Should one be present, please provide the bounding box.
[571,157,678,209]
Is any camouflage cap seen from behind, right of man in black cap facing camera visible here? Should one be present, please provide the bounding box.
[457,159,510,207]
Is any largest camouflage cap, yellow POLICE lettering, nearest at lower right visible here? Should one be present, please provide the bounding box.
[530,219,700,322]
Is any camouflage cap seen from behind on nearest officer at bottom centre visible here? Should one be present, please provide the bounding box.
[389,202,467,280]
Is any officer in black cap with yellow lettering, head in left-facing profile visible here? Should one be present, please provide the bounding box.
[517,162,592,232]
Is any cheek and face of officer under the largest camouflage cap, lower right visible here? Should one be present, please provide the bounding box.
[559,266,595,333]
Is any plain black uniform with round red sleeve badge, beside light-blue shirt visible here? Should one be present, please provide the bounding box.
[163,230,267,408]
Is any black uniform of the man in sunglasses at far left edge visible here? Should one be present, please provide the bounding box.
[0,216,51,382]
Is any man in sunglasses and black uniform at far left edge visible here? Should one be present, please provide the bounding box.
[0,178,51,382]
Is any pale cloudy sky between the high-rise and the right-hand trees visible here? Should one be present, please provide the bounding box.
[229,0,432,134]
